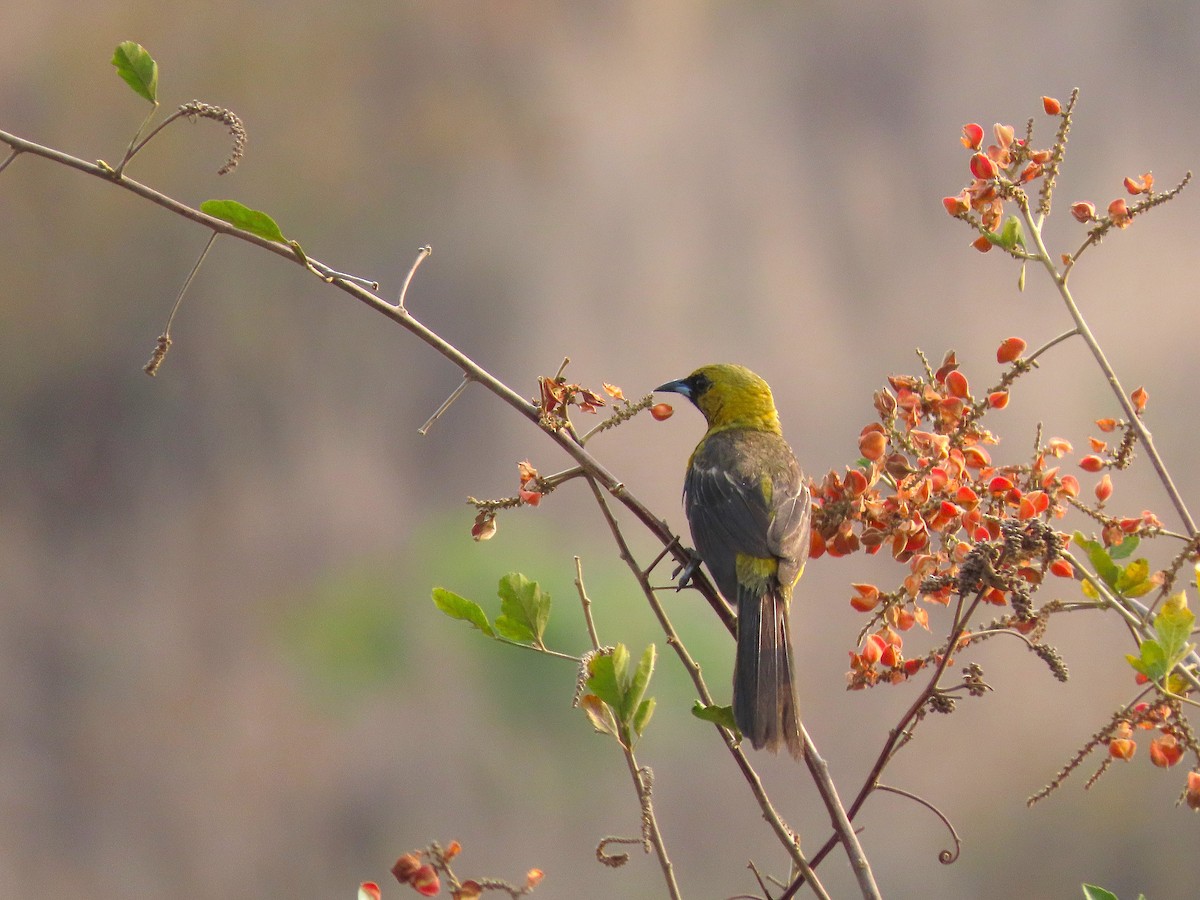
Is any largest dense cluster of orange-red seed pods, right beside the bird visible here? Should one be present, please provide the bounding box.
[811,337,1160,689]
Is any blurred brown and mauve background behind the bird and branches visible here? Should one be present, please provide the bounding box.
[0,0,1200,899]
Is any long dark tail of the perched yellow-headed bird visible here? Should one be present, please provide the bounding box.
[733,586,804,760]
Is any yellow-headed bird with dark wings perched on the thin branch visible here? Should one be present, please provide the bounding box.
[655,364,812,758]
